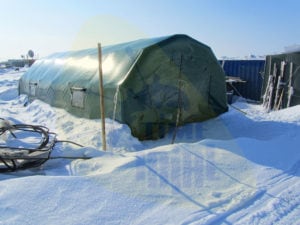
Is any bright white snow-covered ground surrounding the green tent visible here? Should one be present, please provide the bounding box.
[0,71,300,225]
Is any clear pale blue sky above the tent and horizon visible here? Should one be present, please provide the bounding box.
[0,0,300,59]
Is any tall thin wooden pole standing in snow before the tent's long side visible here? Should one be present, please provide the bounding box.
[98,43,106,151]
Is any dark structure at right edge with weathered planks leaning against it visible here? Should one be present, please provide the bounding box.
[261,52,300,109]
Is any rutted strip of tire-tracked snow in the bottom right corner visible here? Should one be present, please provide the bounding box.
[182,160,300,225]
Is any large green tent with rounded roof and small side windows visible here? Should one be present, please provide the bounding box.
[19,35,228,140]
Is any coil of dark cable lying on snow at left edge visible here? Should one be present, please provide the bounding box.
[0,118,86,172]
